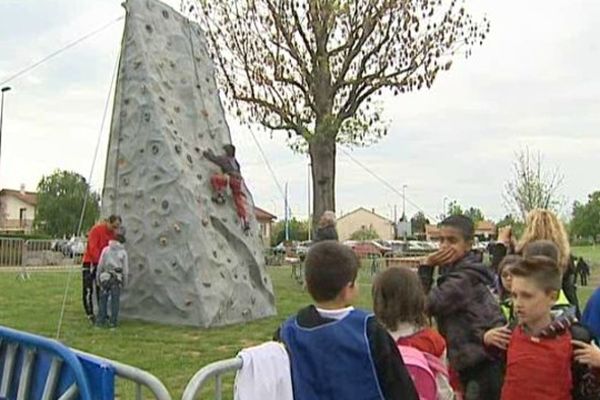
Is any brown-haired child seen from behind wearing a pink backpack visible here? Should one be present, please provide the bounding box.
[372,268,454,400]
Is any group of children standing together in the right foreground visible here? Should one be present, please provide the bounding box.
[276,216,600,400]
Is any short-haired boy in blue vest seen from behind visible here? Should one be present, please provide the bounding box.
[276,241,418,400]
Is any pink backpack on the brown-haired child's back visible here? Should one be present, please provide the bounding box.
[398,346,454,400]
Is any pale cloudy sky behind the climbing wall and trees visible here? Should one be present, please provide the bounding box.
[0,0,600,219]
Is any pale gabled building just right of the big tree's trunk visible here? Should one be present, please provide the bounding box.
[337,207,394,241]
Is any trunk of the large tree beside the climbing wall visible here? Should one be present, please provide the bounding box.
[308,135,336,236]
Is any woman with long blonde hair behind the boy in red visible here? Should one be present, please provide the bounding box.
[490,209,580,318]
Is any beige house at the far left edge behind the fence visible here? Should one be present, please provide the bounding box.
[0,186,37,233]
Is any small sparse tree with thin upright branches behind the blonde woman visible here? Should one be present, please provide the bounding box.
[503,148,563,221]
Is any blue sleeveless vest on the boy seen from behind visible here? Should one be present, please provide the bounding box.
[281,310,384,400]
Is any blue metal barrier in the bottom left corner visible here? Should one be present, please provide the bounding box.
[0,326,115,400]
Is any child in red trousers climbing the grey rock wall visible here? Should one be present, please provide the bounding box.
[203,144,250,231]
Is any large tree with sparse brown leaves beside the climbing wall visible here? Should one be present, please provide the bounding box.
[181,0,489,227]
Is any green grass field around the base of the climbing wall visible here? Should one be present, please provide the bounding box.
[0,247,600,399]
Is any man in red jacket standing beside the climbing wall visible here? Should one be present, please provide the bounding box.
[81,215,121,323]
